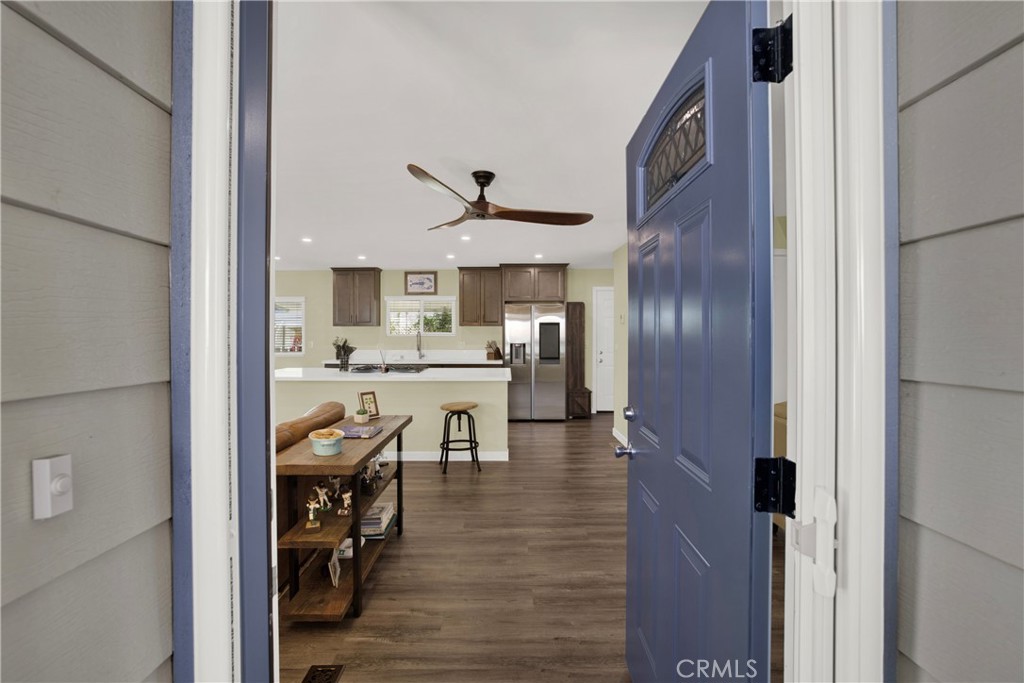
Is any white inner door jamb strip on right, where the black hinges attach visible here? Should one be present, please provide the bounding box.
[782,2,837,681]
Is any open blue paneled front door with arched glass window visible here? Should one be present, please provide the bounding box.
[627,0,771,683]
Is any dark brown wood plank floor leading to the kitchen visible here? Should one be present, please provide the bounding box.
[281,414,774,683]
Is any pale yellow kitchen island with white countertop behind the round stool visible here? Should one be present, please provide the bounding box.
[274,367,511,462]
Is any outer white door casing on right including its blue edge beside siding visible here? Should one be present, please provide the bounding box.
[834,0,899,681]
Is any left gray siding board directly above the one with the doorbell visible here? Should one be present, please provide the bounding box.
[0,205,170,401]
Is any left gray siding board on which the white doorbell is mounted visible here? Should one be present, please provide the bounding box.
[2,383,171,605]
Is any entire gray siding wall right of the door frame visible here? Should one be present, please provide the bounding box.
[897,2,1024,681]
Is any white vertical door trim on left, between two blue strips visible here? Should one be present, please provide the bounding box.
[191,2,241,681]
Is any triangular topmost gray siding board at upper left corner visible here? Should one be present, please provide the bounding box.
[8,0,171,112]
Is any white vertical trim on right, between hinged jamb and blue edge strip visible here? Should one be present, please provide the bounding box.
[834,0,896,681]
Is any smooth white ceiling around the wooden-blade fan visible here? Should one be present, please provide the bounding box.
[272,0,707,270]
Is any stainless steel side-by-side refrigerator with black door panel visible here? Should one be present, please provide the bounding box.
[505,303,565,420]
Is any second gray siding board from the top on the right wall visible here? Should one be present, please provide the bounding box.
[899,41,1024,242]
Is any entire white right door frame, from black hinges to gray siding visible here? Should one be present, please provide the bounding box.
[784,0,898,681]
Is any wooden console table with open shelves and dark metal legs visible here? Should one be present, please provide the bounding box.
[276,415,413,622]
